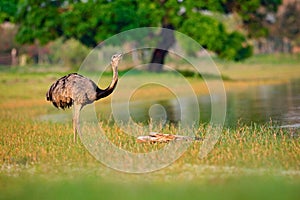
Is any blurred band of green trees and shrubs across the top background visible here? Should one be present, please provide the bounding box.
[0,0,300,71]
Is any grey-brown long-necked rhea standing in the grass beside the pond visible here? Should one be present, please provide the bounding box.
[46,54,122,142]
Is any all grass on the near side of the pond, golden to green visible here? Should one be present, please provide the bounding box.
[0,106,300,199]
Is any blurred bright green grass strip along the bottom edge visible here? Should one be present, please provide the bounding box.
[0,177,300,200]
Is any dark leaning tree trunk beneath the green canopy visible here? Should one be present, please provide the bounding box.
[148,24,175,72]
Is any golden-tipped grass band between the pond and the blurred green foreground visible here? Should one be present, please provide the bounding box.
[0,106,300,174]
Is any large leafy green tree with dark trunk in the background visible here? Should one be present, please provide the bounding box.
[13,0,281,71]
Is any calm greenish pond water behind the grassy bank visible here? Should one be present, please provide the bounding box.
[125,80,300,128]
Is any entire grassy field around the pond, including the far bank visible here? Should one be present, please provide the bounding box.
[0,54,300,200]
